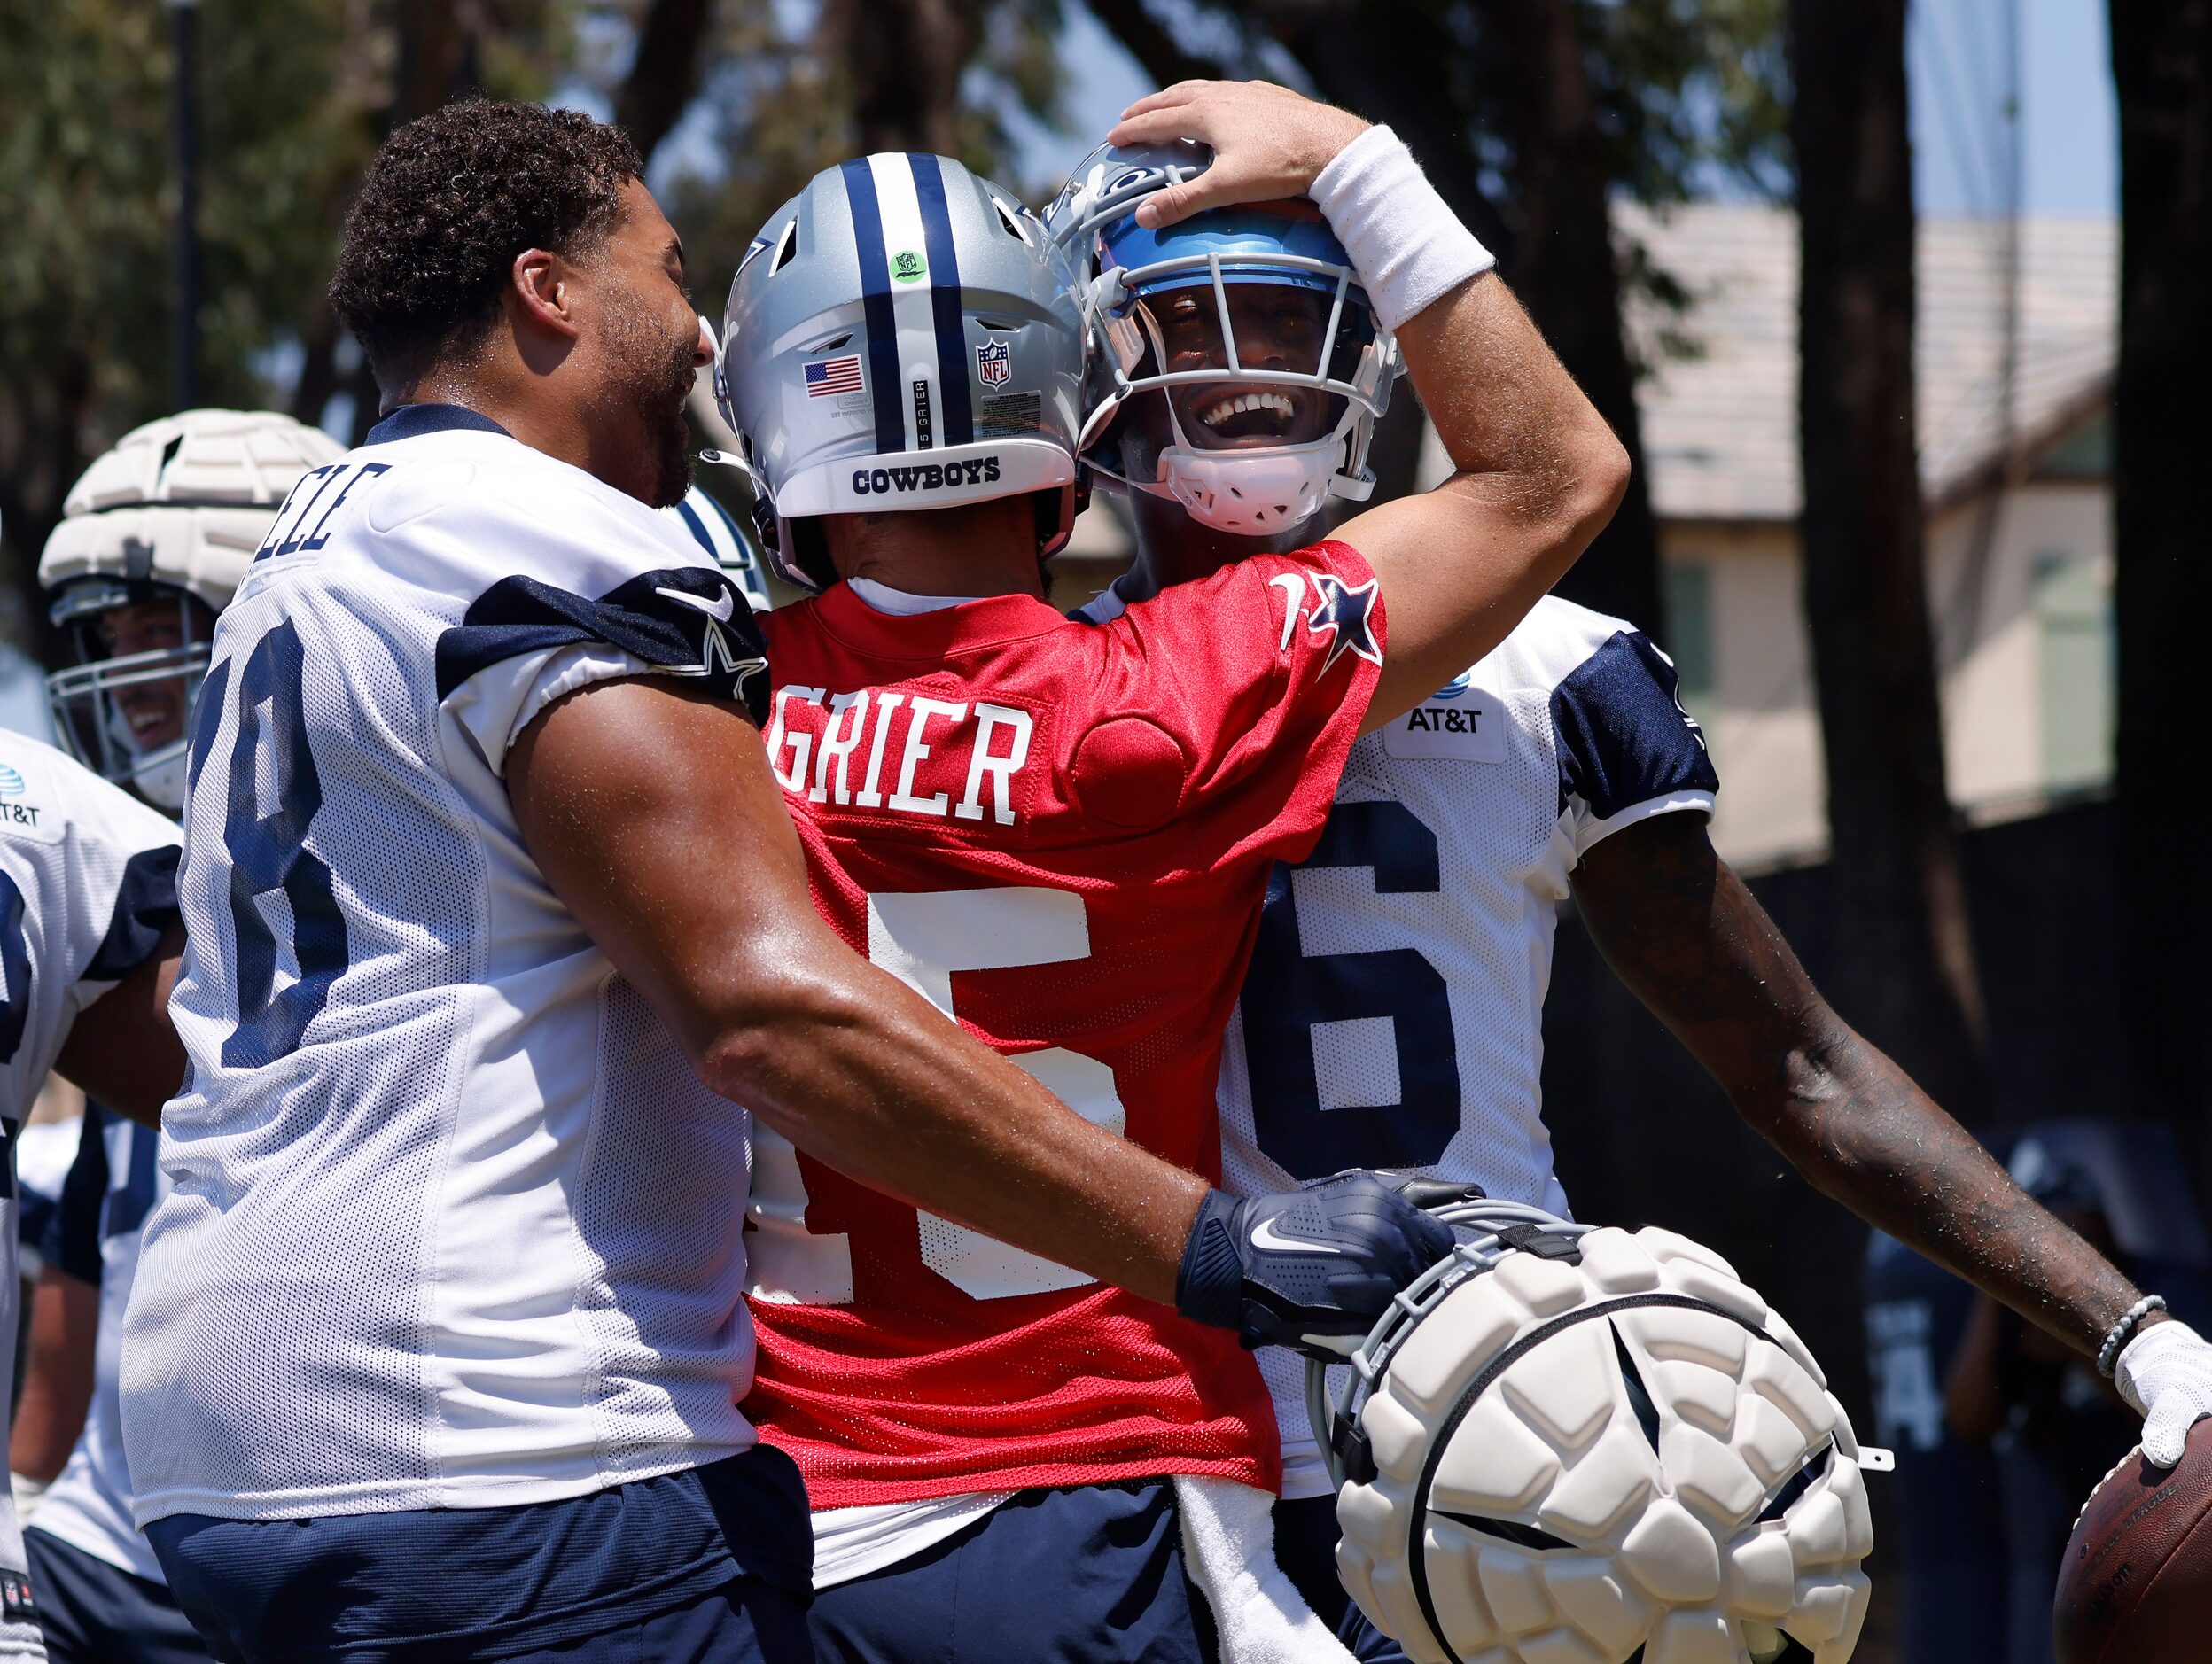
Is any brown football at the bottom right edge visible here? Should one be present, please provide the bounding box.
[2051,1420,2212,1664]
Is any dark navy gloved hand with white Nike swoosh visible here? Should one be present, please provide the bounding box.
[1174,1173,1453,1357]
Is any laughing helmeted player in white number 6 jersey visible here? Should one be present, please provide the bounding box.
[1047,133,2212,1646]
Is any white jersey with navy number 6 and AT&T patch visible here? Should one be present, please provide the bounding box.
[1087,591,1718,1496]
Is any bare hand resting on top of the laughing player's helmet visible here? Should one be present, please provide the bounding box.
[1106,82,1367,230]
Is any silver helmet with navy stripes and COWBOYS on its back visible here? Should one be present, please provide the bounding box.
[710,152,1084,588]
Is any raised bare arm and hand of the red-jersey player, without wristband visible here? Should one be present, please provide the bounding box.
[1106,82,1628,733]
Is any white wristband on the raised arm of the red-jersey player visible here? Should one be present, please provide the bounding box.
[1312,126,1498,330]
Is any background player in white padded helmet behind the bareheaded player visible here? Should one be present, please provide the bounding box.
[24,409,345,1664]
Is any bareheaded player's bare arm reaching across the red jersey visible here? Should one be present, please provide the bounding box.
[507,681,1208,1303]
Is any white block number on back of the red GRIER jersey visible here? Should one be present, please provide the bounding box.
[750,887,1125,1305]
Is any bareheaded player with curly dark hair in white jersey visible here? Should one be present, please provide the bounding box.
[112,102,1436,1660]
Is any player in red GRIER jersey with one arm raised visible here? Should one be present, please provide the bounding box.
[721,84,1624,1664]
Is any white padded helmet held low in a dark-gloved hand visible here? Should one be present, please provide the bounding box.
[1307,1200,1891,1664]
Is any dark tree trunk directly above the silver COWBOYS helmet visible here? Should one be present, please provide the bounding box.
[821,0,982,155]
